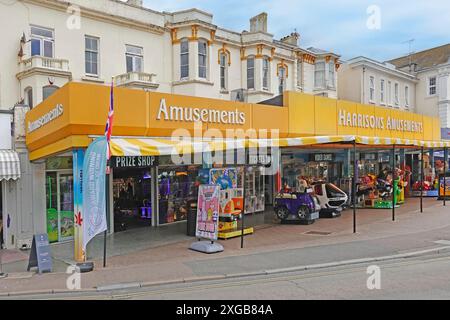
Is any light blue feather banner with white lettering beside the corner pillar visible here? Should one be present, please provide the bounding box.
[82,137,107,250]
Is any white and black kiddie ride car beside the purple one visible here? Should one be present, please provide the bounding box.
[313,182,348,218]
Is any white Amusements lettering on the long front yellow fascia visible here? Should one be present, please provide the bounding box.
[156,99,246,125]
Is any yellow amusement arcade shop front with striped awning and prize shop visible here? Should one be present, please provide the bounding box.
[26,83,448,259]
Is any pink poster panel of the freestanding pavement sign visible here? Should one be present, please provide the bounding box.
[196,185,220,241]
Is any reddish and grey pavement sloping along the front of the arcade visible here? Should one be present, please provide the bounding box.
[0,199,450,297]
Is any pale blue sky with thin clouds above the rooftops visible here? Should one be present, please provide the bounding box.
[144,0,450,61]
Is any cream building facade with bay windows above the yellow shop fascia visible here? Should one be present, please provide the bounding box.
[0,0,340,248]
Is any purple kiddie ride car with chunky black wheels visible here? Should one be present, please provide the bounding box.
[274,190,320,224]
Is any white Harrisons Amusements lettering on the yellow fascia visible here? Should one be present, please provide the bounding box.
[338,109,423,133]
